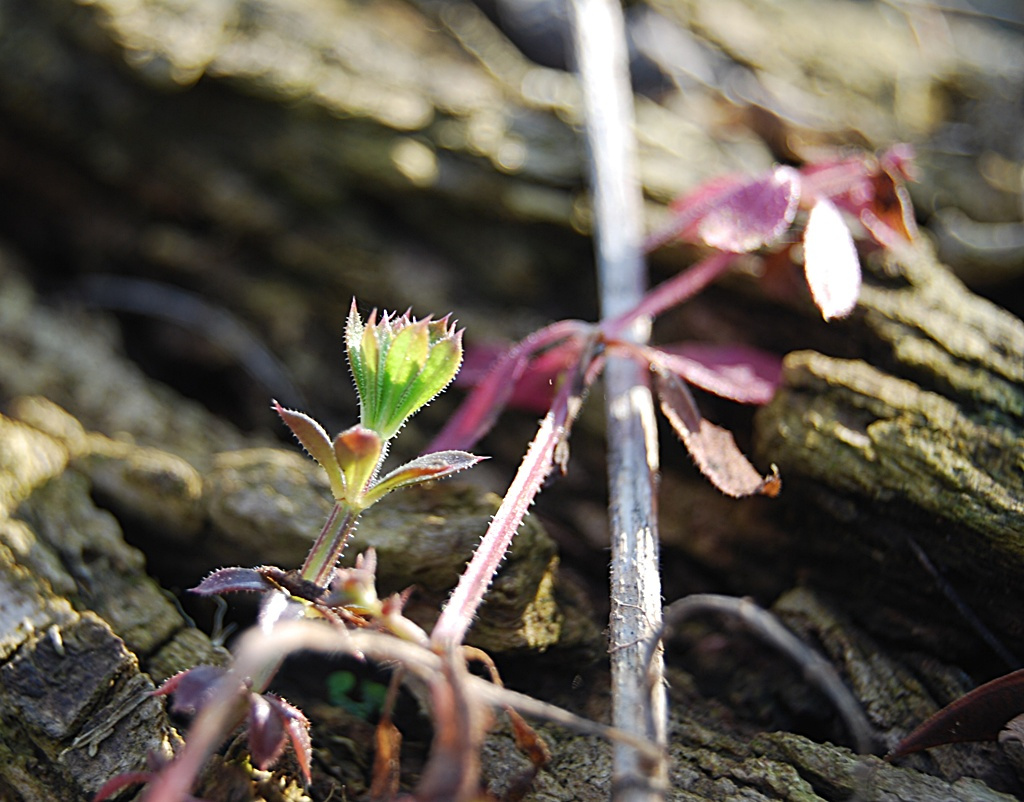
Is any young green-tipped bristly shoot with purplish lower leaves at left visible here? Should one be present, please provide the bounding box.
[96,300,481,800]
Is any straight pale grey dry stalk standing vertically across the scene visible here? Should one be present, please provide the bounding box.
[571,0,667,802]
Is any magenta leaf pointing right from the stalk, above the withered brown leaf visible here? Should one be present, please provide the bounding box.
[644,343,782,404]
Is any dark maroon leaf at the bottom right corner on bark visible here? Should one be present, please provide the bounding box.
[886,669,1024,760]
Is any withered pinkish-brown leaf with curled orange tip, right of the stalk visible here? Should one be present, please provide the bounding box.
[654,370,781,498]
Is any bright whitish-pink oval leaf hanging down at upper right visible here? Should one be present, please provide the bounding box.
[804,199,860,321]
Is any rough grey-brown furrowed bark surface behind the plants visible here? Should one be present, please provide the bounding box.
[0,0,1024,800]
